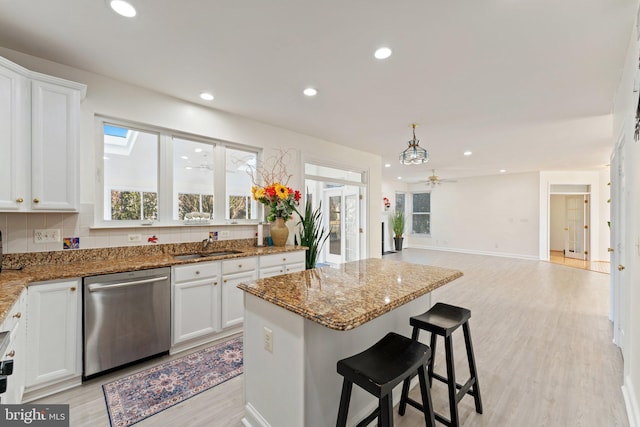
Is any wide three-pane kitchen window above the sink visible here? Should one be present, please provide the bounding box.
[97,118,258,225]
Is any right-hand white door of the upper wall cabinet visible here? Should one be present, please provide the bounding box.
[31,80,80,211]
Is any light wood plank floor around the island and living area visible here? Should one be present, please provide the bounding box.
[38,249,629,427]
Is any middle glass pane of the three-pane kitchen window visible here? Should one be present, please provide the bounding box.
[173,137,214,220]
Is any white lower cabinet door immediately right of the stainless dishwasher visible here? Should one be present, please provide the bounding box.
[172,276,220,344]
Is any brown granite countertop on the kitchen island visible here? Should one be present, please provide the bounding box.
[238,259,462,331]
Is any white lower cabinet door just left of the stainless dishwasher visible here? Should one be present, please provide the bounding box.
[26,279,82,387]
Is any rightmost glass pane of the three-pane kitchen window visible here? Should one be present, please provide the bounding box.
[225,147,258,219]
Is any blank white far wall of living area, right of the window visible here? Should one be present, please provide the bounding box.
[408,172,539,259]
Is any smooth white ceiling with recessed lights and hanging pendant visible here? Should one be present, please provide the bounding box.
[0,0,637,182]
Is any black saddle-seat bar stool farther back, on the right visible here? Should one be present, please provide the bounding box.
[399,302,482,427]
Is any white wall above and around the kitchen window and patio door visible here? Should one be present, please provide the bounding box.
[0,47,382,256]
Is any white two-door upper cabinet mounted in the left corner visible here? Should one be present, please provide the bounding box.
[0,57,86,212]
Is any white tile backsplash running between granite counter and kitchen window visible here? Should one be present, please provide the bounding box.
[0,204,257,253]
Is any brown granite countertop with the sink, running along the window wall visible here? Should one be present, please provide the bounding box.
[0,246,306,323]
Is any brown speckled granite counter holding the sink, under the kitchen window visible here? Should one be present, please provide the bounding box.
[0,245,306,323]
